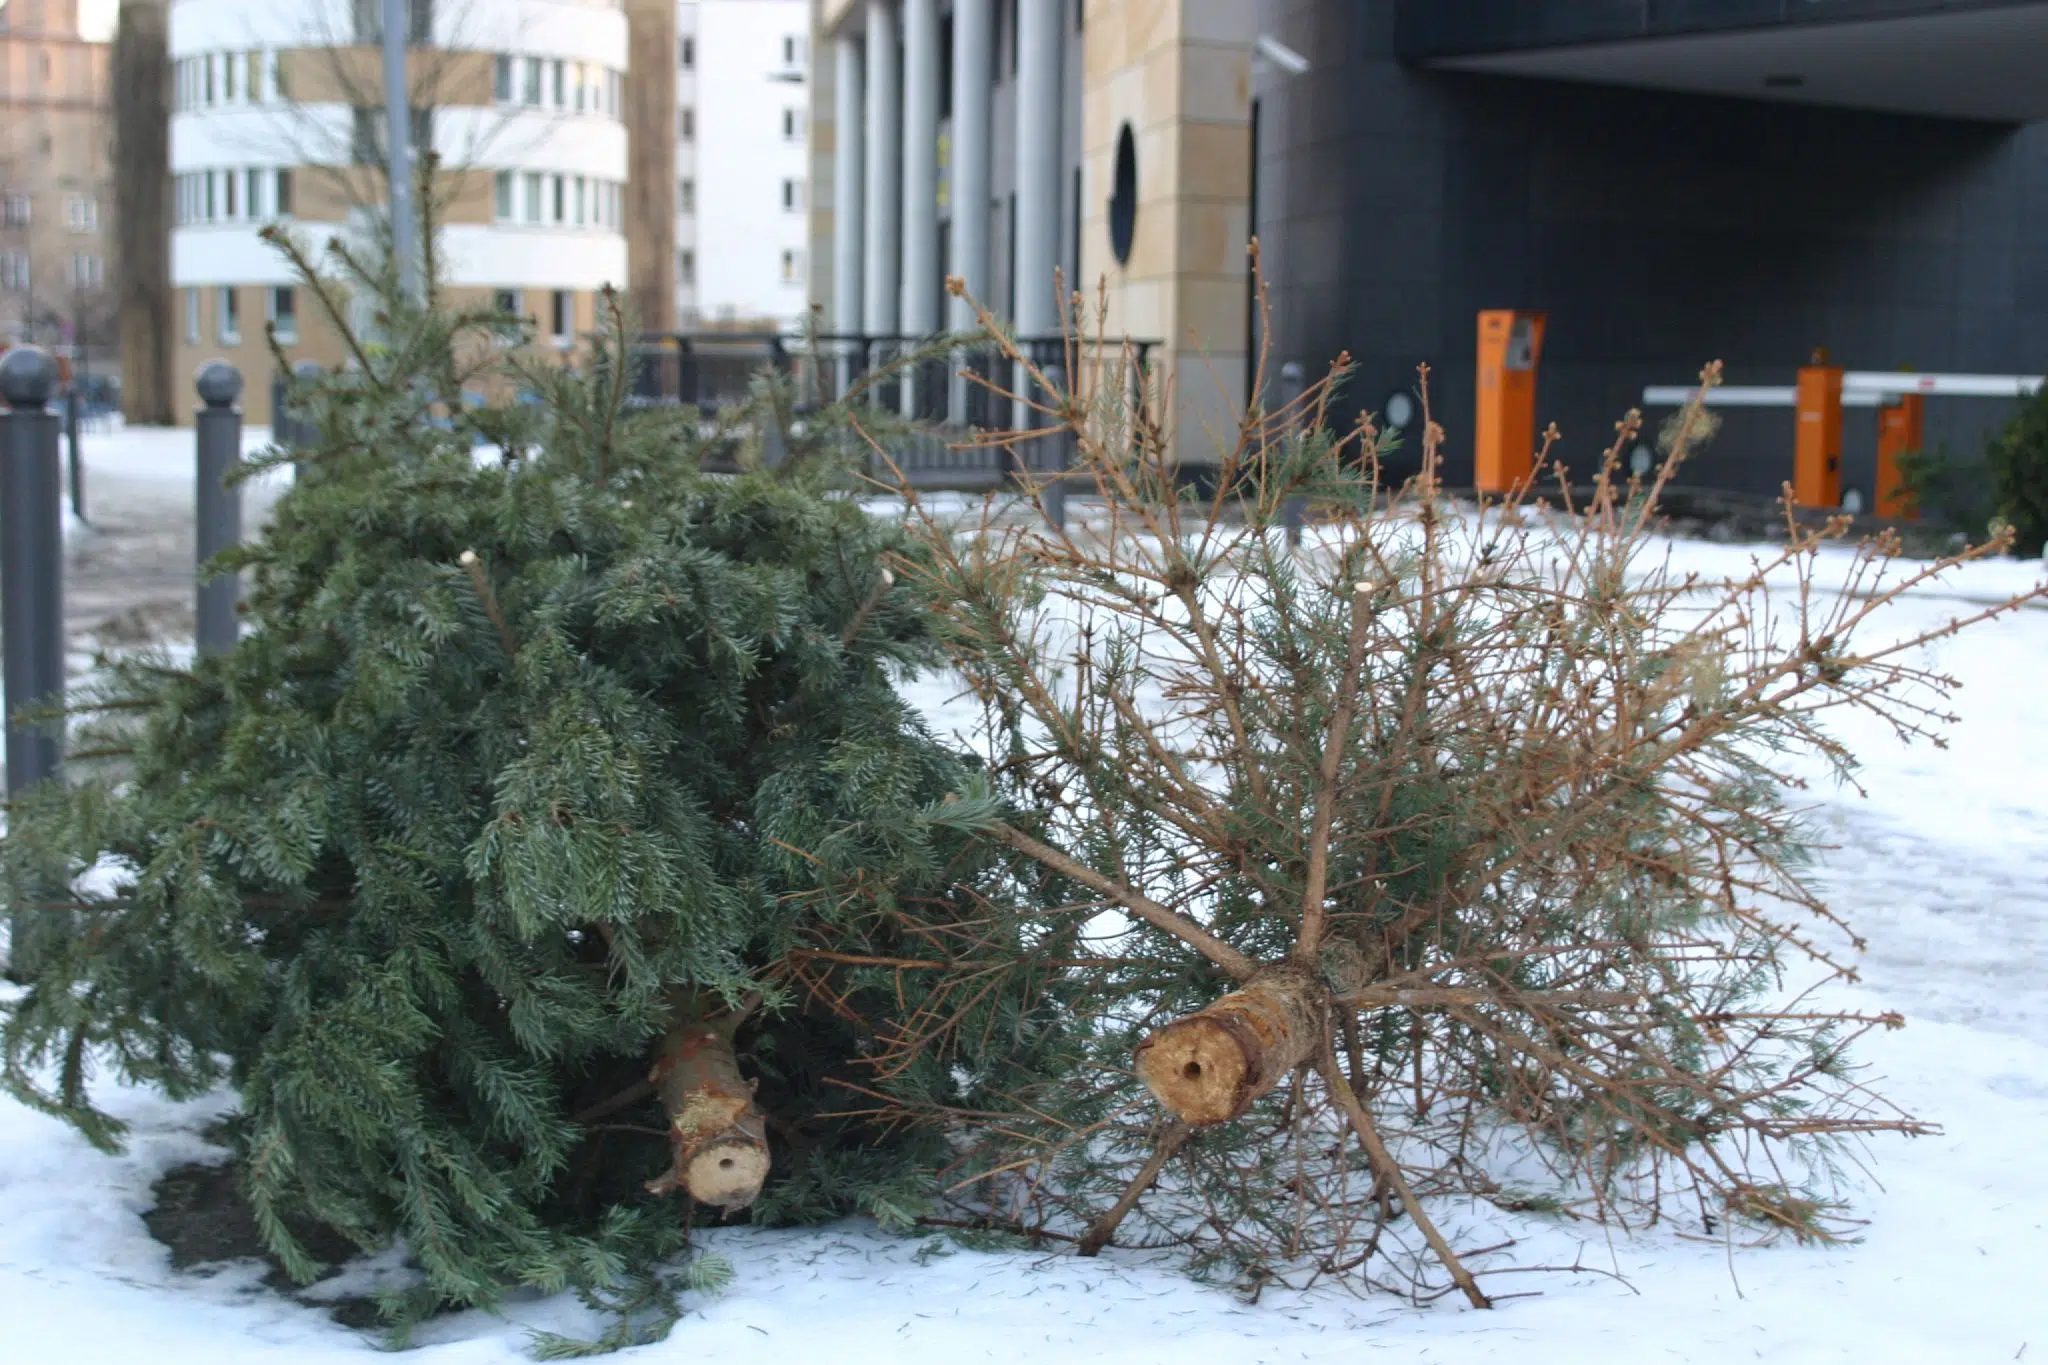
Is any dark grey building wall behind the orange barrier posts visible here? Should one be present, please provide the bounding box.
[1257,0,2048,493]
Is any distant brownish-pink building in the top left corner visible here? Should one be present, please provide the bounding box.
[0,0,115,372]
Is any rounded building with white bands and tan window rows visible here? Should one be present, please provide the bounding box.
[170,0,630,422]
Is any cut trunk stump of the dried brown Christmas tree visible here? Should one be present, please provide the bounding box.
[1137,964,1329,1128]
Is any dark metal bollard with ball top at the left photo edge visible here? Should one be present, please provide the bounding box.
[0,346,63,798]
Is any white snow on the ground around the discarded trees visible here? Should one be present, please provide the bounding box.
[0,442,2048,1365]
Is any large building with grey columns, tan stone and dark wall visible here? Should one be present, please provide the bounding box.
[809,0,2048,493]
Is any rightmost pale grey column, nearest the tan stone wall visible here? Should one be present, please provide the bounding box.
[1014,0,1073,426]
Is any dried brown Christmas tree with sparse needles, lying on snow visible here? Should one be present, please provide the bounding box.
[881,274,2040,1306]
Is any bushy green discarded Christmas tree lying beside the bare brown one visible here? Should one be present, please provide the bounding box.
[0,232,1073,1349]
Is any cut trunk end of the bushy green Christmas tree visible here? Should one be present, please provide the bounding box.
[647,1017,768,1214]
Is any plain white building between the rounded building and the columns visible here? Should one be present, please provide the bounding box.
[676,0,811,329]
